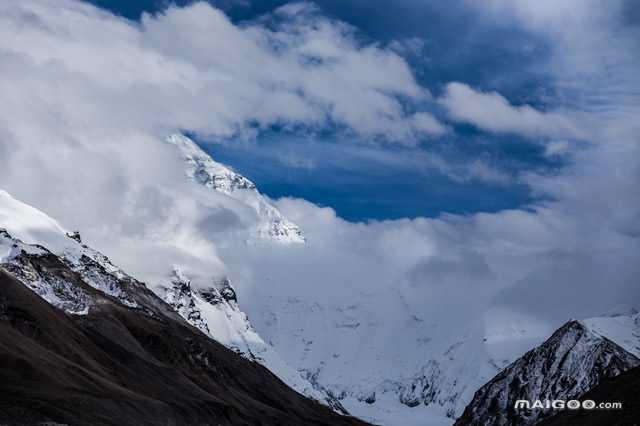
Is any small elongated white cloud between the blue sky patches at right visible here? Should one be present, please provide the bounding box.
[439,82,582,138]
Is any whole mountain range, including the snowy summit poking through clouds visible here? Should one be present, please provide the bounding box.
[0,135,640,425]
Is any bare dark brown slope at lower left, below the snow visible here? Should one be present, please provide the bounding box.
[0,253,364,426]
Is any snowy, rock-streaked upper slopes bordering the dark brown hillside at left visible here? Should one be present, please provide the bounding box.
[0,191,345,412]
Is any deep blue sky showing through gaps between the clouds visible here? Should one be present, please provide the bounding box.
[86,0,559,221]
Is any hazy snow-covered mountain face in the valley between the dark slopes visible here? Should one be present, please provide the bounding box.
[245,292,541,426]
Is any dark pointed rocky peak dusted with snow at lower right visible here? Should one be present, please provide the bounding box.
[456,312,640,426]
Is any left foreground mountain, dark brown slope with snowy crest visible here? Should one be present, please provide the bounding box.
[0,198,361,426]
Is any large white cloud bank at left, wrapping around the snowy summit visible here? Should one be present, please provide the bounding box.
[0,0,442,277]
